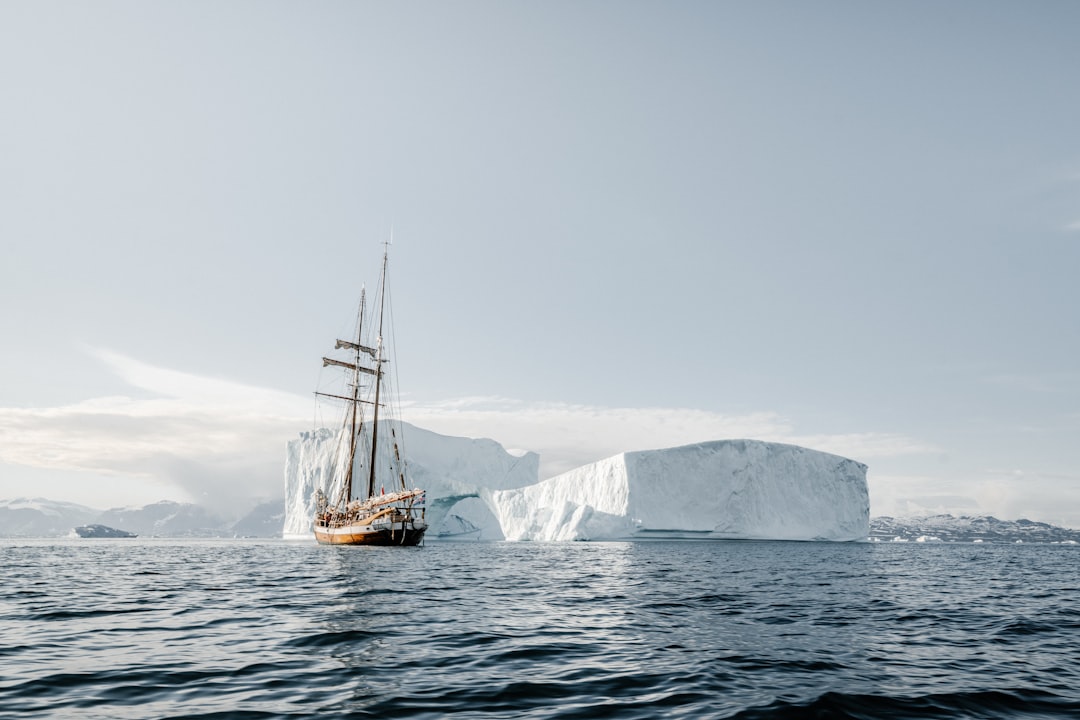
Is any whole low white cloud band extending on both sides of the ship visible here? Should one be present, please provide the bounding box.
[0,349,936,502]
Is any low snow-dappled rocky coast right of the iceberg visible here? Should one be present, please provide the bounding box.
[870,515,1080,543]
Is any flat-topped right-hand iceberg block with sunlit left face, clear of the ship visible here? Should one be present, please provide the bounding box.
[482,440,869,541]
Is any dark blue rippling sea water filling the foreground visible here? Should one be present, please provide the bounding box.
[0,539,1080,718]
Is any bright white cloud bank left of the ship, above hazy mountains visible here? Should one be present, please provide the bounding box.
[0,350,310,501]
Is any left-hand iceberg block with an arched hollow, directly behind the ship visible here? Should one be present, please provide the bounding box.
[283,423,540,540]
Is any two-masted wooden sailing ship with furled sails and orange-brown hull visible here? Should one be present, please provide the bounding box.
[314,250,428,545]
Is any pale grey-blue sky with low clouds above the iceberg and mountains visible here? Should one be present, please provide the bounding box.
[0,0,1080,527]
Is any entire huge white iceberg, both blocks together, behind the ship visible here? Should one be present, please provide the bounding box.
[284,424,869,541]
